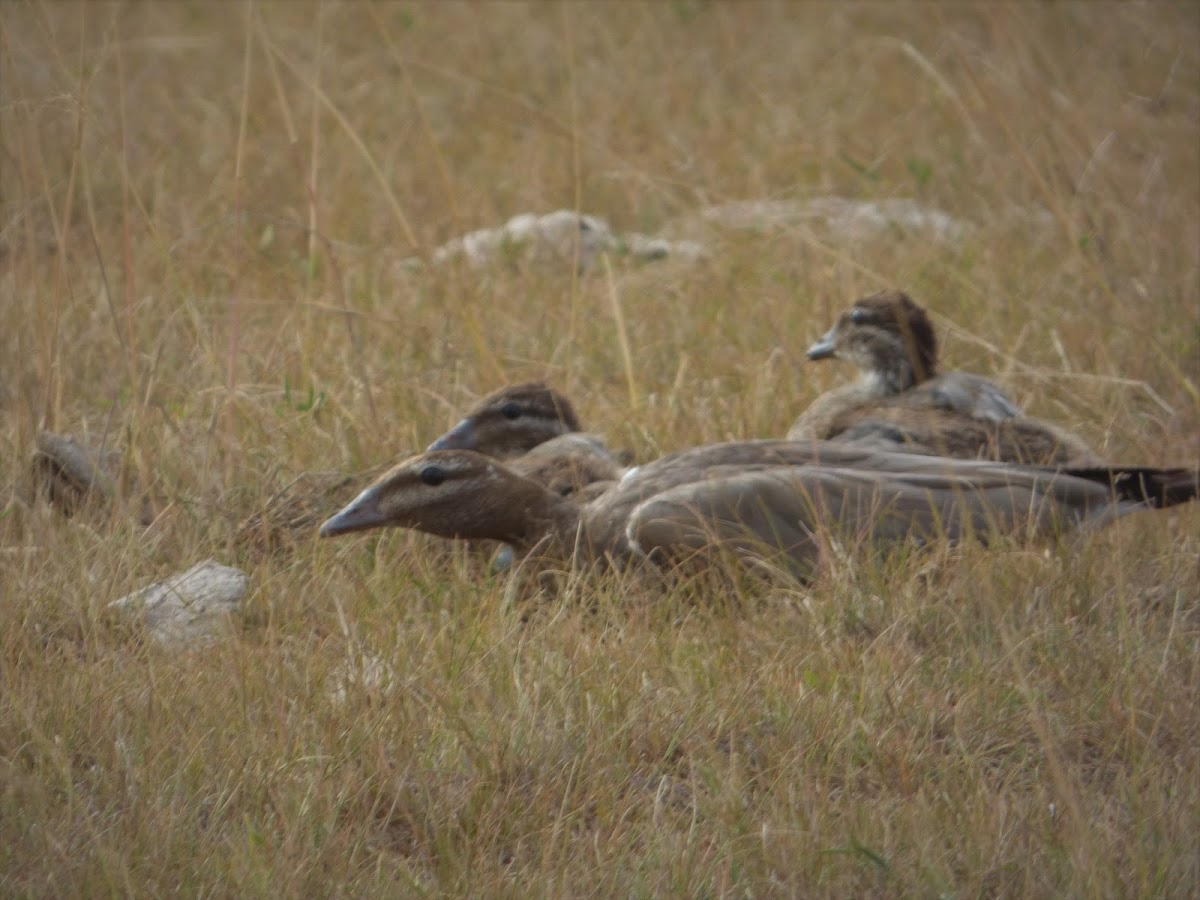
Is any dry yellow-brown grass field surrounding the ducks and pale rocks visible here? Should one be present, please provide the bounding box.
[0,0,1200,898]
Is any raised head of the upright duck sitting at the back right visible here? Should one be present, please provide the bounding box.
[808,290,937,392]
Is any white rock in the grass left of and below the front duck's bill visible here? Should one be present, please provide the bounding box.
[109,559,250,643]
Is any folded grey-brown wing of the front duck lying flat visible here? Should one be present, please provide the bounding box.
[625,466,1180,577]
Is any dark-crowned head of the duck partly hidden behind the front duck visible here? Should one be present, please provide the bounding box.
[430,382,580,460]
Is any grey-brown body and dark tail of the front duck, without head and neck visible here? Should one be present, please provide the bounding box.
[586,440,1200,570]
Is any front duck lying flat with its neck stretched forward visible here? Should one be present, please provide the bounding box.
[319,440,1200,578]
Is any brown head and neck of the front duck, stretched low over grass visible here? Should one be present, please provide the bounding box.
[319,450,577,546]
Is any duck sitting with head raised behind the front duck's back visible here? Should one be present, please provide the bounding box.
[787,290,1103,467]
